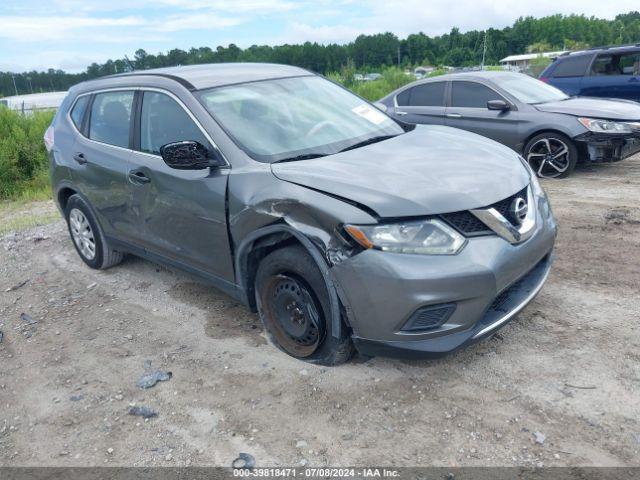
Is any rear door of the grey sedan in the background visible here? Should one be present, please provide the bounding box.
[394,81,447,125]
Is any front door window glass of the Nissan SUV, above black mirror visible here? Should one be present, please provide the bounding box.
[140,92,211,154]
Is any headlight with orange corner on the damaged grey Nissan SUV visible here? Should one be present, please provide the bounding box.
[344,219,466,255]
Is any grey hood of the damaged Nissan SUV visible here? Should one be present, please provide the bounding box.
[271,126,529,217]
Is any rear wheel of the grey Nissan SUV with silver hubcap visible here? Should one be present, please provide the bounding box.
[65,195,123,270]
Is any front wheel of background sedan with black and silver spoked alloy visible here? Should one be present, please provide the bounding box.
[524,132,578,178]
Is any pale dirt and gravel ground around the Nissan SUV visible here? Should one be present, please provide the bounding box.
[0,156,640,466]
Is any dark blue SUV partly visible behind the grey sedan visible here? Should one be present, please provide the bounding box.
[540,44,640,102]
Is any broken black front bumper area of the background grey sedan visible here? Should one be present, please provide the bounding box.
[574,131,640,162]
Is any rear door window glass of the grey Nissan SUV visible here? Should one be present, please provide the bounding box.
[89,92,133,148]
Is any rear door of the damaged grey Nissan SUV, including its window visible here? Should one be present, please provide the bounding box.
[70,90,134,242]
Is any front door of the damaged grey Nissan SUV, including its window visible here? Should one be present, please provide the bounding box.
[128,90,233,281]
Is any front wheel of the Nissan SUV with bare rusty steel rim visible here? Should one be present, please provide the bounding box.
[255,246,353,365]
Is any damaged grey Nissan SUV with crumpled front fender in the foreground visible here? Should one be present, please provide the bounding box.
[45,64,556,365]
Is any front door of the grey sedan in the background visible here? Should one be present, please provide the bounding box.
[446,80,519,148]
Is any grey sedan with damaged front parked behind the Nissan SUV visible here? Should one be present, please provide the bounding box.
[379,71,640,178]
